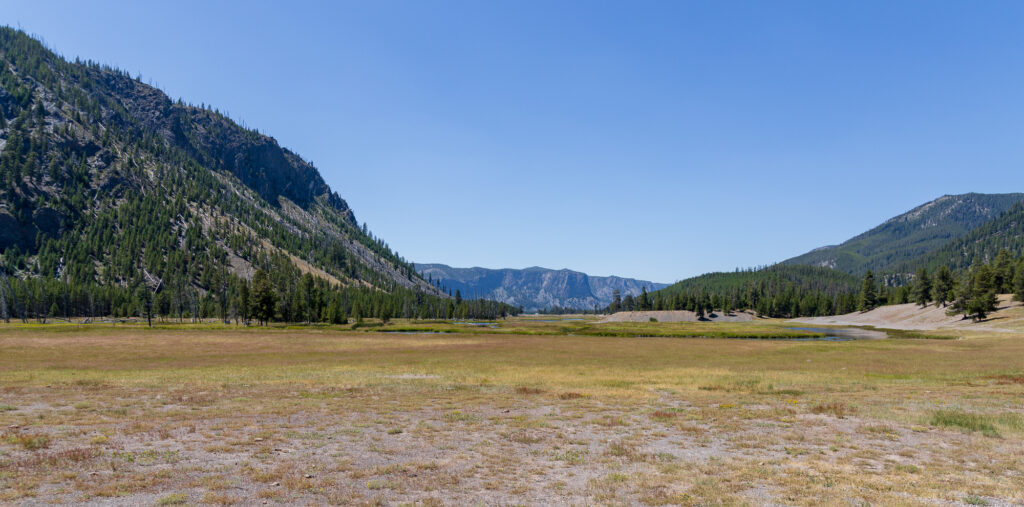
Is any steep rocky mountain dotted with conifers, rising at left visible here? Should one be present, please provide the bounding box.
[0,28,477,316]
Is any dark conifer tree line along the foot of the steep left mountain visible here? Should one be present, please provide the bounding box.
[0,258,520,325]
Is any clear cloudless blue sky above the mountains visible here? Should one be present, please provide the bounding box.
[0,0,1024,282]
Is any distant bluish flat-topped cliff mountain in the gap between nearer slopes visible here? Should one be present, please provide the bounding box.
[416,264,668,311]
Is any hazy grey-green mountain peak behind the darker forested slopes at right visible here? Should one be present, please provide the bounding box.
[783,194,1024,274]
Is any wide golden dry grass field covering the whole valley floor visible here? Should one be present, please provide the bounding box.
[0,309,1024,505]
